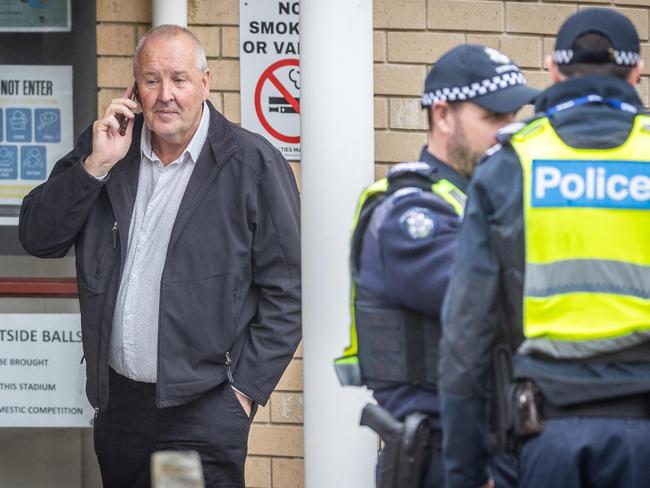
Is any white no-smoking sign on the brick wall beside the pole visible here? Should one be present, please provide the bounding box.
[239,0,300,160]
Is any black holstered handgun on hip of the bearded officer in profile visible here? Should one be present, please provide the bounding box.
[360,403,433,488]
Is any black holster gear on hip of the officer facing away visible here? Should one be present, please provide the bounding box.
[493,344,545,451]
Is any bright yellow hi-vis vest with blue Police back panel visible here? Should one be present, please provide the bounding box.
[512,115,650,349]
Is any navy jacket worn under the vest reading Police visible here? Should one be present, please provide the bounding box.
[440,76,650,488]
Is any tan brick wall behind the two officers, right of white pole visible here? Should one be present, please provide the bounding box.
[374,0,650,176]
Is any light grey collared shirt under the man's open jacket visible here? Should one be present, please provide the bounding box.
[109,103,210,383]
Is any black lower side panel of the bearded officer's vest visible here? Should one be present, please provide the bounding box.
[355,286,440,389]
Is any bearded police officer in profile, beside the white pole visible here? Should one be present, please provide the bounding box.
[336,45,538,488]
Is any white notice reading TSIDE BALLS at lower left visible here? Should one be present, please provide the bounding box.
[0,314,94,427]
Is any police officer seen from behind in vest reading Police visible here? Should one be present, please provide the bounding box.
[440,8,650,488]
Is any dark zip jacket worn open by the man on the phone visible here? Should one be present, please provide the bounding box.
[19,102,301,409]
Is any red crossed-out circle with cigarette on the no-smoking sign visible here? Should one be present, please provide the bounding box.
[255,59,300,144]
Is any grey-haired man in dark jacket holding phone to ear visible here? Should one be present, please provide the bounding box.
[20,25,300,488]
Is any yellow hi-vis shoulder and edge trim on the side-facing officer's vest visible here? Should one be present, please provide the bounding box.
[334,172,466,386]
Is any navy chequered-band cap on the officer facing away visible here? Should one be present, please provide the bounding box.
[553,8,640,66]
